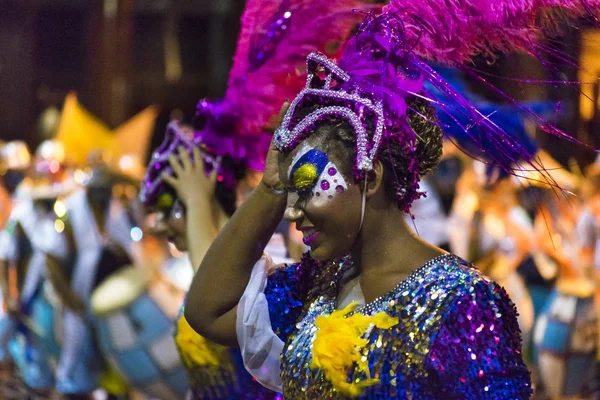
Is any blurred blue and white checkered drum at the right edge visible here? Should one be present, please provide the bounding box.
[534,289,598,398]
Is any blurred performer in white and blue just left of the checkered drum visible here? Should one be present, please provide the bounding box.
[50,155,135,398]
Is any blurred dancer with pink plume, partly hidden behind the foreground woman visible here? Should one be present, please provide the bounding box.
[141,0,379,399]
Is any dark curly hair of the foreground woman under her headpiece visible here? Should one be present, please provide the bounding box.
[290,96,443,209]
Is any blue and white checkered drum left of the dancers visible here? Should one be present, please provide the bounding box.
[91,267,188,400]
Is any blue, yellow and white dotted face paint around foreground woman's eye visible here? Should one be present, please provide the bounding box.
[289,146,348,203]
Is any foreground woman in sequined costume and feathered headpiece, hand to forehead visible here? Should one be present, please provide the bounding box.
[180,1,600,399]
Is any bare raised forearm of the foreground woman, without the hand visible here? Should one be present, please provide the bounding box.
[191,179,287,344]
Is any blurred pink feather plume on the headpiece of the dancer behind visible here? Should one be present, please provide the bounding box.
[222,0,381,135]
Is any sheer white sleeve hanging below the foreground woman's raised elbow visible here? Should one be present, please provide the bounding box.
[236,255,283,392]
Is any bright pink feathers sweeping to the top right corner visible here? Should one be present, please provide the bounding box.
[384,0,600,66]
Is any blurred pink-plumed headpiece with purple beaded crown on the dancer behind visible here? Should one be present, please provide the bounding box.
[141,0,381,208]
